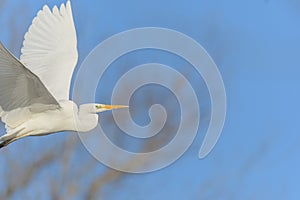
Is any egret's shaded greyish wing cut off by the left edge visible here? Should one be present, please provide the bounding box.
[0,42,59,112]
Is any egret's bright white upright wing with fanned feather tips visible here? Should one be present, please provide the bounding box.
[21,1,78,101]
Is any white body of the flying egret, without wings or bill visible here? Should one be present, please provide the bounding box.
[0,100,98,141]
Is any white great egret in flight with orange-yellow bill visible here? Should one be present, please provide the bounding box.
[0,1,127,148]
